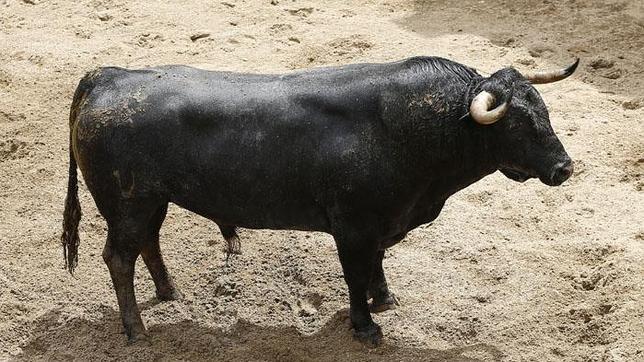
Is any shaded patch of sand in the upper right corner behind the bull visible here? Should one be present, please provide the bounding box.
[397,0,644,97]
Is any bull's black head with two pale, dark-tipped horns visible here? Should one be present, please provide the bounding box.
[470,59,579,186]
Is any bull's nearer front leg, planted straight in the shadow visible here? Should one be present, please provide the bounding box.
[335,236,382,346]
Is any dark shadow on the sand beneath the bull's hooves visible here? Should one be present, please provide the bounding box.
[16,301,503,362]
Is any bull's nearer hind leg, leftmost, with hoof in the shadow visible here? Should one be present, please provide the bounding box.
[102,199,165,342]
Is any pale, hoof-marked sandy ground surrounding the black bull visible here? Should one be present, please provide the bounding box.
[0,0,644,361]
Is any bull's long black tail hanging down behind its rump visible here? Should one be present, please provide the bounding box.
[60,74,92,274]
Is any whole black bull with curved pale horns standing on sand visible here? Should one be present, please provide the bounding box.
[62,57,577,344]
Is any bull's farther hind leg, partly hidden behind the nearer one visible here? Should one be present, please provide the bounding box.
[141,204,183,301]
